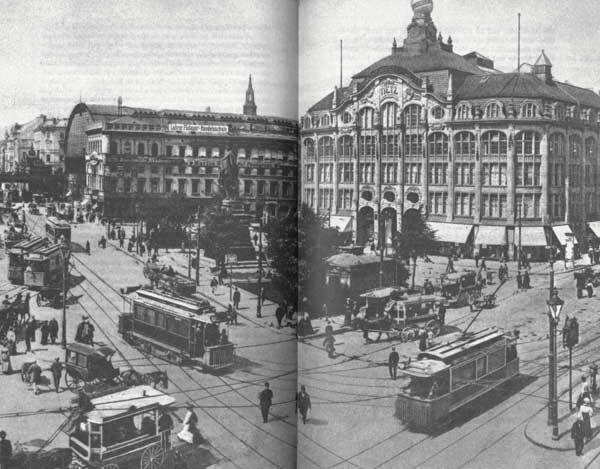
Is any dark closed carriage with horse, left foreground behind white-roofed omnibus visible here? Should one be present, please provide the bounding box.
[65,342,169,392]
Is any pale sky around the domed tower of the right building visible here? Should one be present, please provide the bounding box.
[298,0,600,115]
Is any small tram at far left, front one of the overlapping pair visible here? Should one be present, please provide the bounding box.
[24,244,63,290]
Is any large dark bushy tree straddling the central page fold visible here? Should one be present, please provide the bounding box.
[266,204,342,305]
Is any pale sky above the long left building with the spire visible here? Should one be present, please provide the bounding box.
[0,0,298,127]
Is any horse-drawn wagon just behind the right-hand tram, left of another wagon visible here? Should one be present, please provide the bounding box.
[354,287,445,342]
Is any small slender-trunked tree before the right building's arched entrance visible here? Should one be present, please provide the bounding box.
[394,210,436,288]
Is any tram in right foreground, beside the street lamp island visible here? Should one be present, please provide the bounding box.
[396,328,519,432]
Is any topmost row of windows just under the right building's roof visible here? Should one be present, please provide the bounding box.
[302,102,600,129]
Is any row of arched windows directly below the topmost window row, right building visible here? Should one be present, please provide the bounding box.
[303,130,560,159]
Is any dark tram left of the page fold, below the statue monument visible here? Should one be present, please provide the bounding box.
[119,289,234,371]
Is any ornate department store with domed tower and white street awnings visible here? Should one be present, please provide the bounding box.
[301,0,600,257]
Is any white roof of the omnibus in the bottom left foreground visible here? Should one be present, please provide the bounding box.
[87,385,175,423]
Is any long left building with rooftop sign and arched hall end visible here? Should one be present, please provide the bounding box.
[67,81,298,219]
